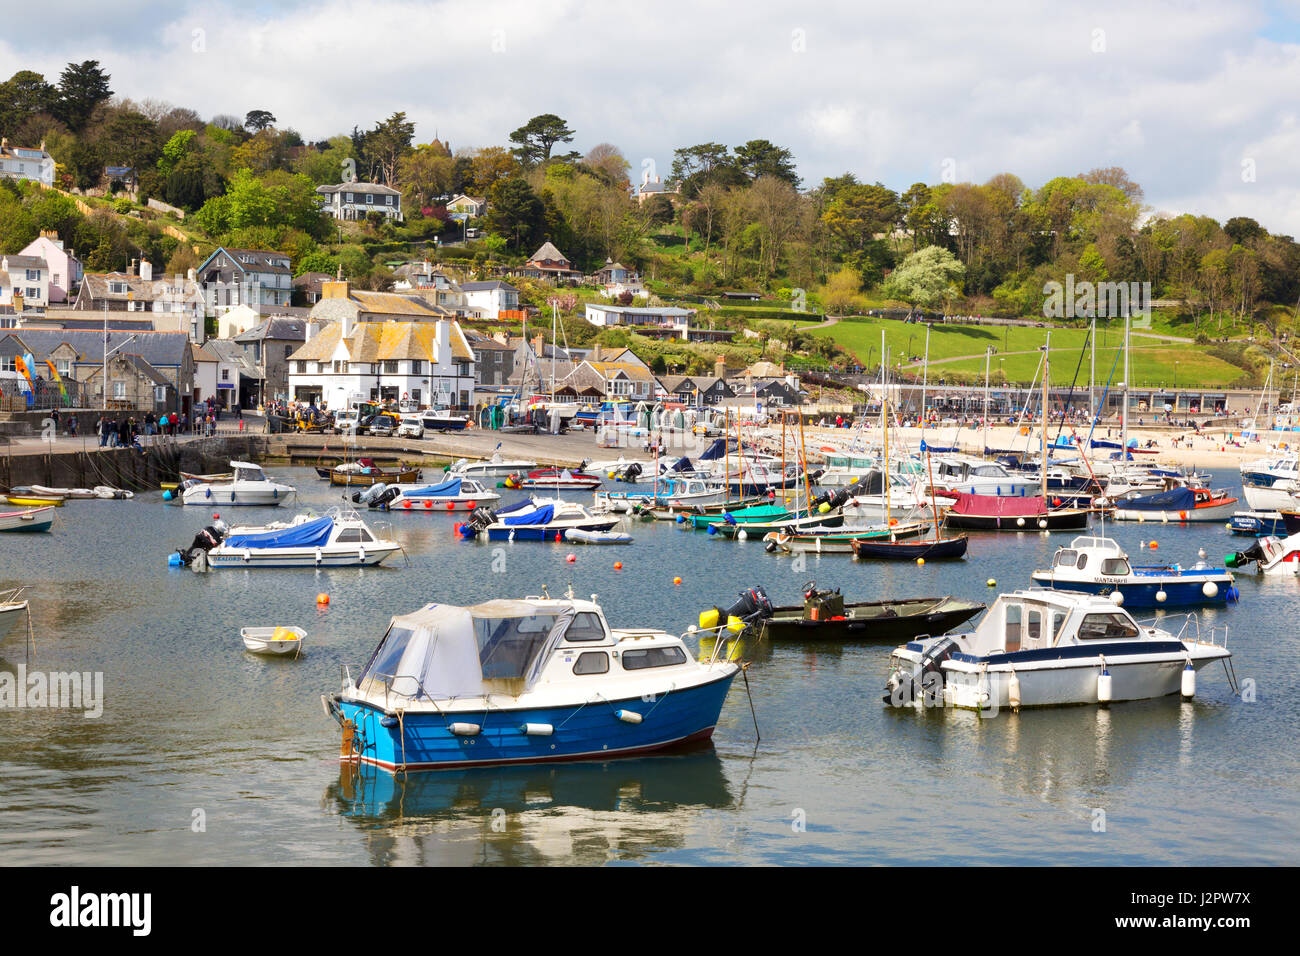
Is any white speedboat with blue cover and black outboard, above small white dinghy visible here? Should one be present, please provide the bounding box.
[207,509,402,568]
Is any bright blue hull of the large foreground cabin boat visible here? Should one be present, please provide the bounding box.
[335,667,738,771]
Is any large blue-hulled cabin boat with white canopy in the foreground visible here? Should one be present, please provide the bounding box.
[321,596,740,773]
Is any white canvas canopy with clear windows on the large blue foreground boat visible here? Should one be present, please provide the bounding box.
[358,600,575,700]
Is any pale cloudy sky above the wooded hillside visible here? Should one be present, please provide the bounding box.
[0,0,1300,237]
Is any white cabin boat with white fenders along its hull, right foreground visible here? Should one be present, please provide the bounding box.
[884,588,1231,713]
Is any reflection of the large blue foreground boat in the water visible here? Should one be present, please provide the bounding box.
[322,743,735,865]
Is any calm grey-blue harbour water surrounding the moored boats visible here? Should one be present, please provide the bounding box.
[0,468,1300,865]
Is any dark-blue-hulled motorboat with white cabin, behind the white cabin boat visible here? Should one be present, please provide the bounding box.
[1031,536,1239,607]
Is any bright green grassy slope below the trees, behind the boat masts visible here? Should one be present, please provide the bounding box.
[780,319,1244,388]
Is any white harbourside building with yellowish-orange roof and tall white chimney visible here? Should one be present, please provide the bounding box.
[289,316,475,408]
